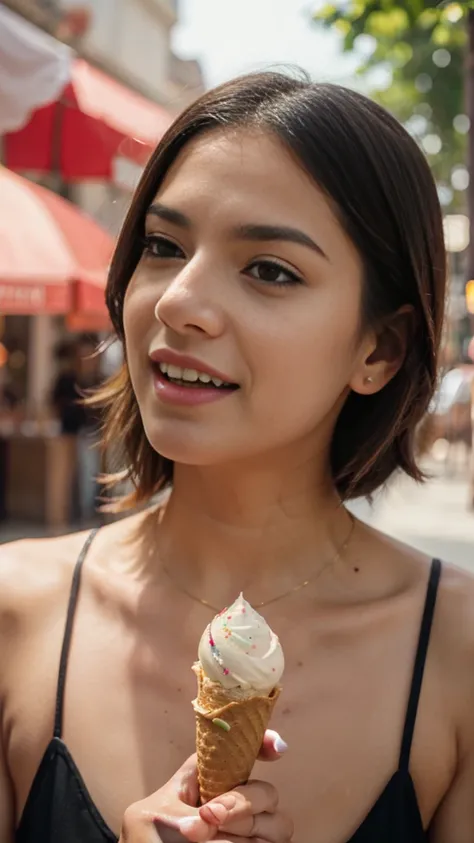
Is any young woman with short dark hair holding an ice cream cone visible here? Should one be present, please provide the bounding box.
[0,73,474,843]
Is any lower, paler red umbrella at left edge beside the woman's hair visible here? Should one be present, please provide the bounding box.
[0,167,114,314]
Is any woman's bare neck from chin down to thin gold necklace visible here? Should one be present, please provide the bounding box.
[151,452,350,609]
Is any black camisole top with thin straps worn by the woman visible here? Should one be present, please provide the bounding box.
[15,531,441,843]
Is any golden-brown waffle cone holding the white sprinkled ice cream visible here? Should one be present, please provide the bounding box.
[193,663,280,804]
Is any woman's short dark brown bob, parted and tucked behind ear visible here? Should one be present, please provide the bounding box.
[98,72,446,505]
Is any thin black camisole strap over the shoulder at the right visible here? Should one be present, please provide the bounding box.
[399,559,441,770]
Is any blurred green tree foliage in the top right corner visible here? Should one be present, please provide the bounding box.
[314,0,474,210]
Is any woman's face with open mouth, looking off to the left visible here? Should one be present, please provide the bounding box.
[124,131,365,474]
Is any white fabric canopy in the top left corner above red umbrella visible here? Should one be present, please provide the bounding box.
[0,4,73,135]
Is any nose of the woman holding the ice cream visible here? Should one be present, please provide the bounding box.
[155,255,224,337]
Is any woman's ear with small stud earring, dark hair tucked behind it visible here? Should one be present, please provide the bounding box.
[349,305,416,395]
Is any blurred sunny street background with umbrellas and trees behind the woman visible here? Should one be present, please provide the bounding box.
[0,0,474,570]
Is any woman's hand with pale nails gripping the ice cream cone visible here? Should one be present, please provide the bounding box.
[119,730,293,843]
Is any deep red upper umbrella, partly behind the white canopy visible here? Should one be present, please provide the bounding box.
[4,59,173,182]
